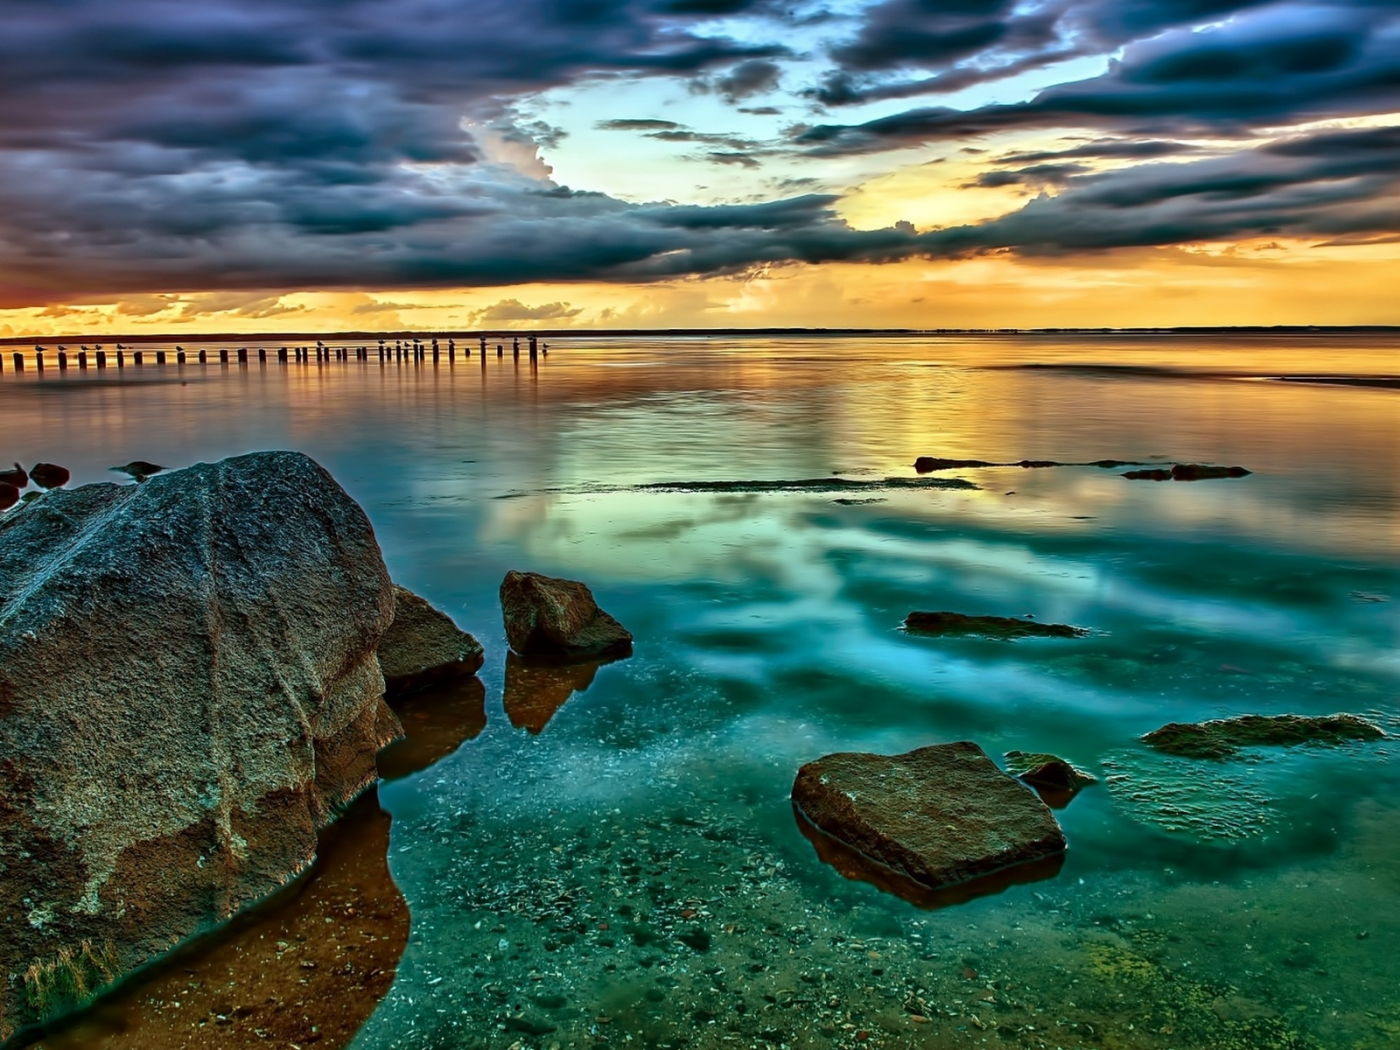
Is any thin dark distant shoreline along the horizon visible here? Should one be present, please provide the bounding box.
[0,325,1400,347]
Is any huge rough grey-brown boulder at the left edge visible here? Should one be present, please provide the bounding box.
[0,452,399,1039]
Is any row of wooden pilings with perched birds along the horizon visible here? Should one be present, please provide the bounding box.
[0,336,549,372]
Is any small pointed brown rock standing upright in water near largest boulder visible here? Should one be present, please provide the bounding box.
[501,571,631,661]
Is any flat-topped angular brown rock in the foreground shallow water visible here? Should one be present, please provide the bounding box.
[792,742,1065,889]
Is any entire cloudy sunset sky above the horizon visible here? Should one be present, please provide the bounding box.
[0,0,1400,337]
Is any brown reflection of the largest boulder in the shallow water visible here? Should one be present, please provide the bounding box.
[31,790,409,1050]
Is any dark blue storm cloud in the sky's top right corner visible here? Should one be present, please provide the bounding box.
[798,0,1400,155]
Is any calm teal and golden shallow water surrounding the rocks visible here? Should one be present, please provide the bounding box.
[0,336,1400,1050]
